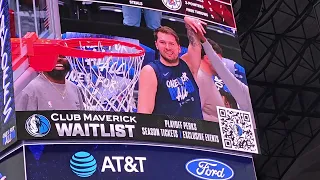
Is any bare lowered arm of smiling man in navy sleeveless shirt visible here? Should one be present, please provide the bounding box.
[138,65,158,114]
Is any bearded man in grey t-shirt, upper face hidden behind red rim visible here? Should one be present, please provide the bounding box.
[15,56,84,111]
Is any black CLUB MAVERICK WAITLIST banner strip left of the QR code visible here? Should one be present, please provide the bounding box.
[17,111,260,154]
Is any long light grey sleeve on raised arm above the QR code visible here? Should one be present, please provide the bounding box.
[202,41,255,123]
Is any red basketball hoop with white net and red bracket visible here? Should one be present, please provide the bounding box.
[11,31,145,112]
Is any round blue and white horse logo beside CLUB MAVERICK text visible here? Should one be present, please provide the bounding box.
[25,114,51,137]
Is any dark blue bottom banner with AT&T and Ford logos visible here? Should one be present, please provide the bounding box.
[23,144,256,180]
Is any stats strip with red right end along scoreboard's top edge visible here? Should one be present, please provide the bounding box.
[86,0,236,29]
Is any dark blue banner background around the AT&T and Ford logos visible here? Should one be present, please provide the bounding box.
[26,144,255,180]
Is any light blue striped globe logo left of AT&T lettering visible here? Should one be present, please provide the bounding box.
[70,151,97,178]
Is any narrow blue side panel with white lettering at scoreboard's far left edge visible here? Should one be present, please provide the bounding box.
[0,0,16,151]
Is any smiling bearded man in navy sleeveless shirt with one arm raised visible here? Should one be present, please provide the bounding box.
[138,17,205,119]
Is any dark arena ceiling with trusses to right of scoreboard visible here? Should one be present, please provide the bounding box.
[233,0,320,180]
